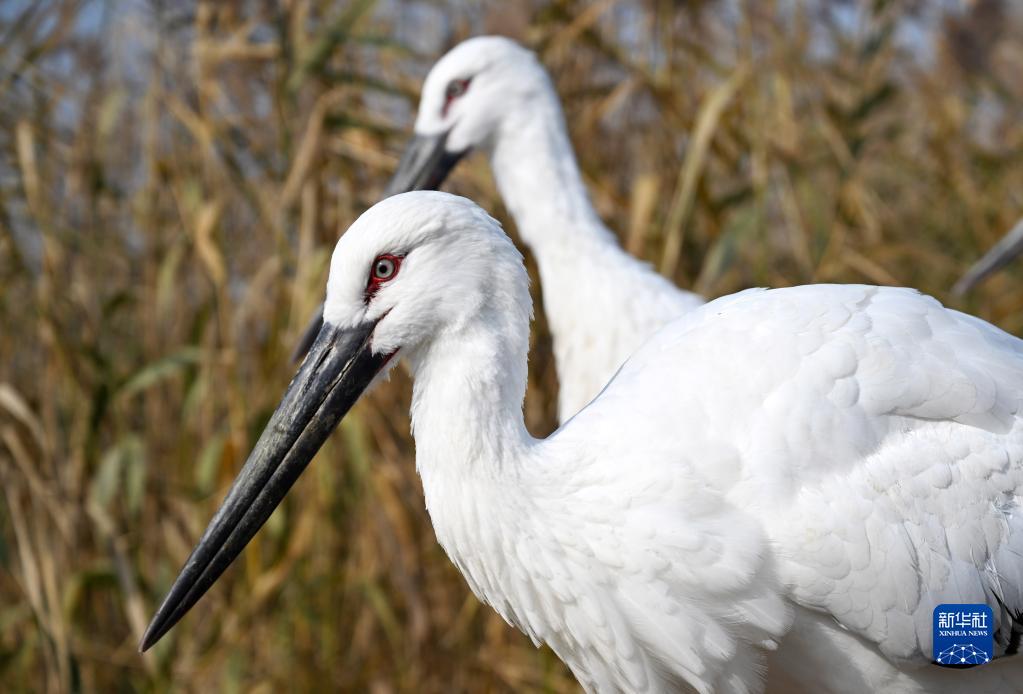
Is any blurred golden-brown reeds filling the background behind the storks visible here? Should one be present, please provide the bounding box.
[0,0,1023,692]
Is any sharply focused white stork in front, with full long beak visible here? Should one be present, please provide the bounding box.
[141,192,1023,694]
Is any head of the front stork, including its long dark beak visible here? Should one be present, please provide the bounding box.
[140,192,529,651]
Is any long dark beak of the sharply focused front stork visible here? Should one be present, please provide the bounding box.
[139,321,392,651]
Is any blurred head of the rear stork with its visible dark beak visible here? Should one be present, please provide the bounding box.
[387,36,550,194]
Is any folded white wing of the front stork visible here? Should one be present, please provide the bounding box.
[578,286,1023,662]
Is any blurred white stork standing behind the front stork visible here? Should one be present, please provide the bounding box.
[299,37,704,422]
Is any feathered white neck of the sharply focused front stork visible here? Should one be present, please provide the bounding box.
[409,296,536,616]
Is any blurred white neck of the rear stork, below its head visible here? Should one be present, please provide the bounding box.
[490,76,703,423]
